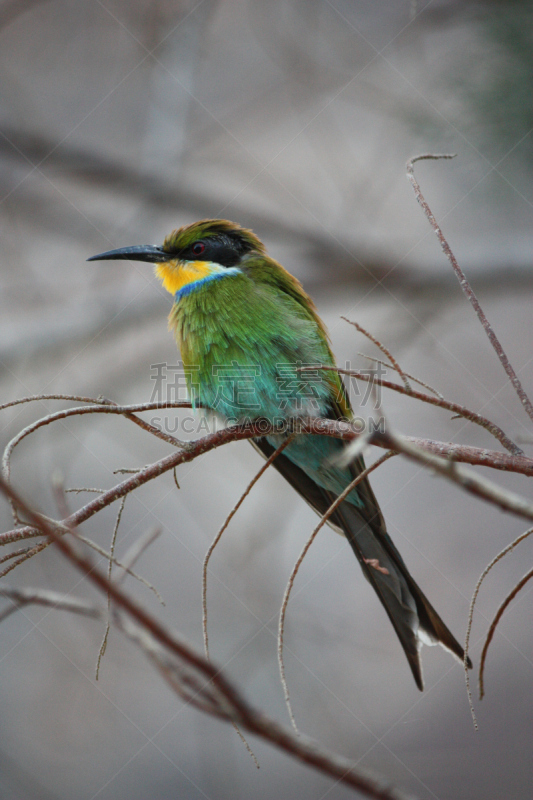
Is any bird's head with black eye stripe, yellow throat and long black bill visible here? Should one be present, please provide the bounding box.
[87,219,265,295]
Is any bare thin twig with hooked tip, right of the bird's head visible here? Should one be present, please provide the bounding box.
[406,153,533,428]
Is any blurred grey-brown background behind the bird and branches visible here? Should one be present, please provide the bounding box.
[0,0,533,800]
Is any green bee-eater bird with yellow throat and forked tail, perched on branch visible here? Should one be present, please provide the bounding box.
[88,219,470,689]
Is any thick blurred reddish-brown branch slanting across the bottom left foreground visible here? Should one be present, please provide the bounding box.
[0,478,414,800]
